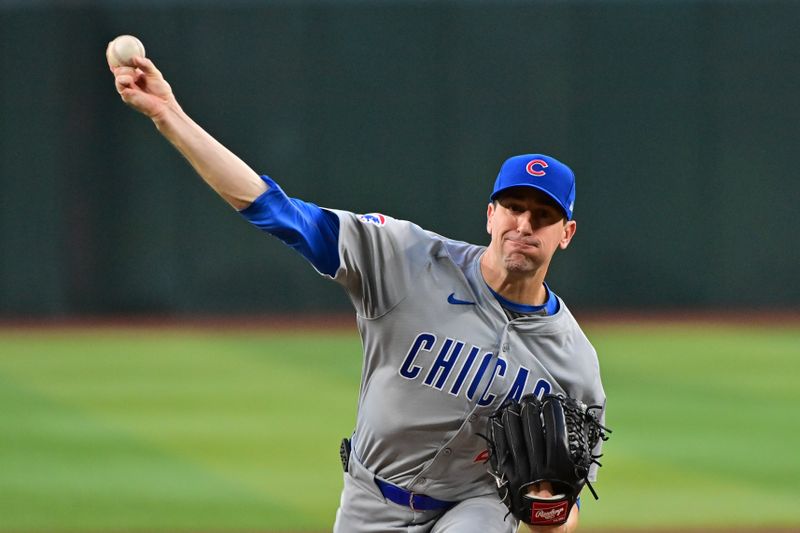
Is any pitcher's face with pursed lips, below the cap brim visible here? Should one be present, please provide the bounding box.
[486,187,575,273]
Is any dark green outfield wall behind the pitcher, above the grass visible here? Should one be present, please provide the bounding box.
[0,0,800,317]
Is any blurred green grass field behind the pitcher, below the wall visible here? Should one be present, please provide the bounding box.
[0,325,800,532]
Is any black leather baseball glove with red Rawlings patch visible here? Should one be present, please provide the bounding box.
[486,394,611,525]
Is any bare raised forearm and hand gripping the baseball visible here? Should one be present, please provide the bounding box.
[106,43,267,210]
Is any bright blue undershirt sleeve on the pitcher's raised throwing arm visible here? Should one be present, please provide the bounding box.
[239,176,339,277]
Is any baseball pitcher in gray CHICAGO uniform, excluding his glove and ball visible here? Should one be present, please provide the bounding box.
[110,50,605,533]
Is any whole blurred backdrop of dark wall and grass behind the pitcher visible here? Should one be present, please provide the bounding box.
[0,0,800,532]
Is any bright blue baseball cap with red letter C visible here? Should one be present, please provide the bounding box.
[489,154,575,220]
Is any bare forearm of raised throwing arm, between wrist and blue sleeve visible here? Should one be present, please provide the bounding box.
[153,103,267,210]
